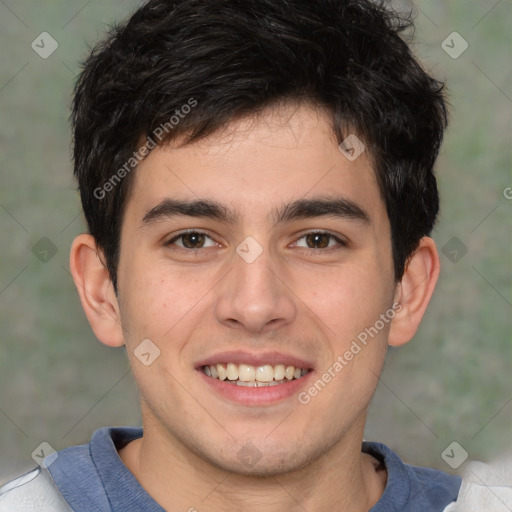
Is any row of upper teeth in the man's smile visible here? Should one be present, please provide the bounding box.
[203,363,308,382]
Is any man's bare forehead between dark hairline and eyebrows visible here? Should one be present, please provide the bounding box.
[127,105,387,225]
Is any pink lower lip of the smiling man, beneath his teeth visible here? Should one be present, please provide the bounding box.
[198,370,314,405]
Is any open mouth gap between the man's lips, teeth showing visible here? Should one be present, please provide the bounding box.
[202,363,310,388]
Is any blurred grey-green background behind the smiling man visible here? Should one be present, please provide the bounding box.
[0,0,512,483]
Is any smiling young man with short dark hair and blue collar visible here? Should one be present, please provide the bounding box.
[0,0,508,512]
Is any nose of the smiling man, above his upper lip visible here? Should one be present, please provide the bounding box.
[215,246,297,334]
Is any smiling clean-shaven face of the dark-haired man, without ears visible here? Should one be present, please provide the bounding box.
[118,106,395,474]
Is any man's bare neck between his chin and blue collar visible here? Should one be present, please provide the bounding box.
[119,418,386,512]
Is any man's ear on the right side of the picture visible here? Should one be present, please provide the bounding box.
[388,237,440,347]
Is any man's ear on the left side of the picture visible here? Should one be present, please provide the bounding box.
[69,234,124,347]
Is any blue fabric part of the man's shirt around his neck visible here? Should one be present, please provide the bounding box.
[43,427,461,512]
